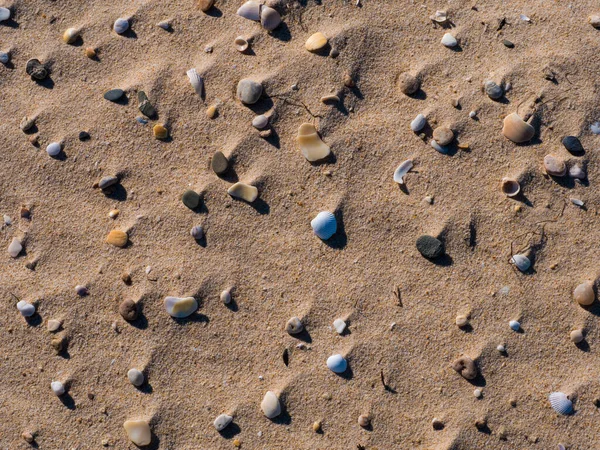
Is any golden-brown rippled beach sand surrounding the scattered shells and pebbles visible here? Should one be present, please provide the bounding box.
[0,0,600,450]
